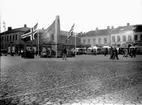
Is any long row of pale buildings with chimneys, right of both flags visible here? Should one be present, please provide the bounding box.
[80,23,142,47]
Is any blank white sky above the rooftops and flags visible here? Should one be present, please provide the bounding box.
[0,0,142,32]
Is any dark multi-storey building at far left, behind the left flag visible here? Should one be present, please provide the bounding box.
[0,25,30,53]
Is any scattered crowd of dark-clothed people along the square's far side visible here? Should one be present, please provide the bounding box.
[1,46,137,60]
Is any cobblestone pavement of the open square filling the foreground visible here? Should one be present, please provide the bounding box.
[0,55,142,105]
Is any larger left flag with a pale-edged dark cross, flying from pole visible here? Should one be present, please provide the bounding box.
[21,23,38,41]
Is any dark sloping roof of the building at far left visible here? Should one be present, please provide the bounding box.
[0,27,30,35]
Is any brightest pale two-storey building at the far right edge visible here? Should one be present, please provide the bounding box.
[110,23,142,47]
